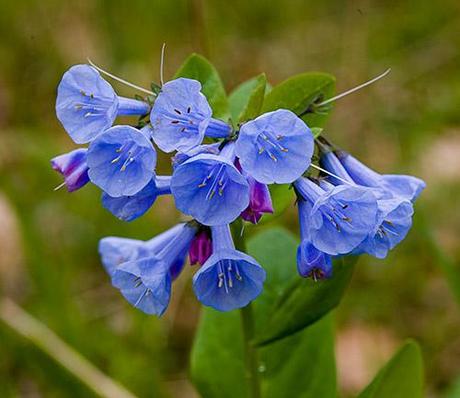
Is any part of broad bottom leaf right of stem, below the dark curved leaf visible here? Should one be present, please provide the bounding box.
[260,316,337,398]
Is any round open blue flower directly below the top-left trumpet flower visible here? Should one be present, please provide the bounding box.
[87,126,157,197]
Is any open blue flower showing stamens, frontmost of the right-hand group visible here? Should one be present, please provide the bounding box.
[294,177,377,256]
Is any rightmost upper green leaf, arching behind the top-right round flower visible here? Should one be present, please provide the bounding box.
[262,72,335,128]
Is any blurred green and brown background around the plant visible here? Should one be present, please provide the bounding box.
[0,0,460,398]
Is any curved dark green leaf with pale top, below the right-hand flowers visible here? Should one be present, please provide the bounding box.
[248,229,355,345]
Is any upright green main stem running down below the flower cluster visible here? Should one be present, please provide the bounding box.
[232,220,262,398]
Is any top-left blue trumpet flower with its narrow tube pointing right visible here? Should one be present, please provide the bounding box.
[56,65,150,144]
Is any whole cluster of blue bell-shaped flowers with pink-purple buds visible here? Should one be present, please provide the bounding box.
[51,65,425,316]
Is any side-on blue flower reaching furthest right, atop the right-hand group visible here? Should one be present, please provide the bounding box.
[337,151,426,202]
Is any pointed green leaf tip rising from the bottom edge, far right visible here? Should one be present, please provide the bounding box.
[358,341,423,398]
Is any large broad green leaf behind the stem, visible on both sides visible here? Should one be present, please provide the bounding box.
[191,229,336,398]
